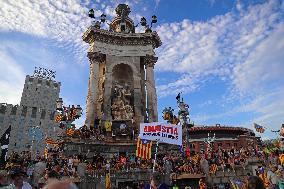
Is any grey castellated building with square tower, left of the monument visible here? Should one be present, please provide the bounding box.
[0,75,61,153]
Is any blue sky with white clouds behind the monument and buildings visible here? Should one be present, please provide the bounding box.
[0,0,284,138]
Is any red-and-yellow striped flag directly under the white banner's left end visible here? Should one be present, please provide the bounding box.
[136,138,152,159]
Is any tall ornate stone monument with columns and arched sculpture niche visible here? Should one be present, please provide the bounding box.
[82,4,161,134]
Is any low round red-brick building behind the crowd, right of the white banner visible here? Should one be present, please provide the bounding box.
[189,125,258,152]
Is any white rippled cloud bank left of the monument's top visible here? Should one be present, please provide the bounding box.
[0,0,116,59]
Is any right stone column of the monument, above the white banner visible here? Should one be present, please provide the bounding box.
[144,55,158,122]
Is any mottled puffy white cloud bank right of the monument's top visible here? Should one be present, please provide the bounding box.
[156,1,283,95]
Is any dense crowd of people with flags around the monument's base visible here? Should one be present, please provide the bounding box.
[0,141,284,188]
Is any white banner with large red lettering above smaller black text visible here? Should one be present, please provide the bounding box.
[139,122,182,145]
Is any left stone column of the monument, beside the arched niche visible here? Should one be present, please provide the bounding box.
[85,52,104,126]
